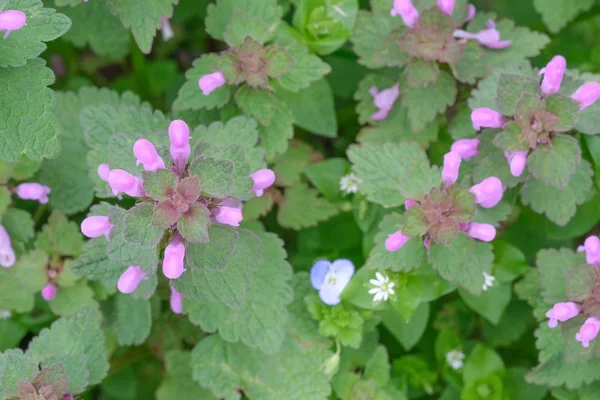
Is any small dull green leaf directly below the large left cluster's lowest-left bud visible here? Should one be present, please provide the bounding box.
[110,293,152,346]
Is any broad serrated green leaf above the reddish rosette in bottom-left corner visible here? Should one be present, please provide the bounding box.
[26,308,109,393]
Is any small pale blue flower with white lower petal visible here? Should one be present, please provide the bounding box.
[310,259,354,306]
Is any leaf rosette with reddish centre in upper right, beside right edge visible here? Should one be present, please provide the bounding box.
[469,64,600,226]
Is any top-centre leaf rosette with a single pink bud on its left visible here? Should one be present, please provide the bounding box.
[173,0,336,158]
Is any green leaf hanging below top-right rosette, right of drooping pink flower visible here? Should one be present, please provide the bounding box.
[400,71,457,132]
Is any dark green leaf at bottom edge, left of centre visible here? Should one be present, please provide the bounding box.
[156,350,216,400]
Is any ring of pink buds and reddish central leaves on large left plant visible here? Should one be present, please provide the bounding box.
[81,120,275,313]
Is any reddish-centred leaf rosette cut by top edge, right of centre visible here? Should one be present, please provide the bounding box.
[351,0,549,139]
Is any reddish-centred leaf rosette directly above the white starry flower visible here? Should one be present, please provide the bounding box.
[348,142,494,294]
